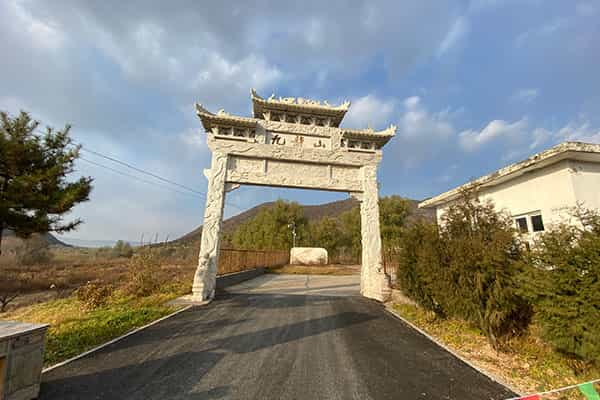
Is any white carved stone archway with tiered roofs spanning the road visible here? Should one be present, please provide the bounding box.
[192,90,396,302]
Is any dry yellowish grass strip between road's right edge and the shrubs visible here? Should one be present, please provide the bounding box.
[392,304,600,400]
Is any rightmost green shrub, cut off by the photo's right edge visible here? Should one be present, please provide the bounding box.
[523,208,600,365]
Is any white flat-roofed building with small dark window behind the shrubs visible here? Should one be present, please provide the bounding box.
[419,142,600,233]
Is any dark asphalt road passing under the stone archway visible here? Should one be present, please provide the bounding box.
[40,275,512,400]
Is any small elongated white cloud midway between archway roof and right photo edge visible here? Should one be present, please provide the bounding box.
[459,118,528,151]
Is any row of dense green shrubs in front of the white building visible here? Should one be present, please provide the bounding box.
[397,191,600,364]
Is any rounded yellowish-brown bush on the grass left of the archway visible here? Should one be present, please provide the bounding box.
[125,248,163,297]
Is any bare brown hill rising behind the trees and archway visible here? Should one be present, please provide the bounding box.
[174,198,435,244]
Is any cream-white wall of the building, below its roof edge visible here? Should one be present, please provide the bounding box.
[436,160,600,232]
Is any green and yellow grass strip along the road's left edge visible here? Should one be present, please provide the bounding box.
[0,284,189,367]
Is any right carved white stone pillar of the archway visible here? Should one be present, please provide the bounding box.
[360,165,391,301]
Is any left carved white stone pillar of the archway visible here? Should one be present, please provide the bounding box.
[192,152,227,302]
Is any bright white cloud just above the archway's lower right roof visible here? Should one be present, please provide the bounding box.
[344,94,396,129]
